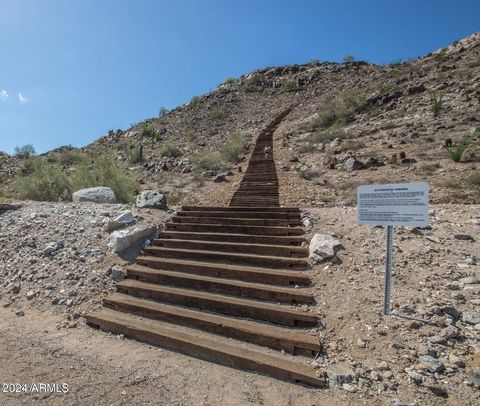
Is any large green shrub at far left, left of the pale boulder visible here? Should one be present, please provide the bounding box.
[12,159,71,202]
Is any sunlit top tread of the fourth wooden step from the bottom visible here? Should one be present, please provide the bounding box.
[127,265,313,298]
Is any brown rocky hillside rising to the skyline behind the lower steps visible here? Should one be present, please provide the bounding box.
[0,33,480,205]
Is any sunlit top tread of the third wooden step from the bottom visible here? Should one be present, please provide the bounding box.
[117,279,317,321]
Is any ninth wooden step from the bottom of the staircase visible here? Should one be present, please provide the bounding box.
[165,223,305,236]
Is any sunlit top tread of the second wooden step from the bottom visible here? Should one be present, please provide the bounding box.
[104,293,320,351]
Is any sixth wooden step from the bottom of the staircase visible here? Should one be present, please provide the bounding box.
[144,246,308,269]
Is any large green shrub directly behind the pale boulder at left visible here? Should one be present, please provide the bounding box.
[70,154,137,203]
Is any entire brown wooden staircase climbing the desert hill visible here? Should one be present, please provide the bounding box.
[86,111,325,386]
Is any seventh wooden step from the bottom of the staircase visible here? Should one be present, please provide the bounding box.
[153,238,308,258]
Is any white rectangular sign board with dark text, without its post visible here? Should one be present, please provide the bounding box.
[357,182,428,227]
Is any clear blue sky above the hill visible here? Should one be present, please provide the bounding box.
[0,0,480,153]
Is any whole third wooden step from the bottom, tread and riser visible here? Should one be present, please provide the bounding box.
[116,279,318,327]
